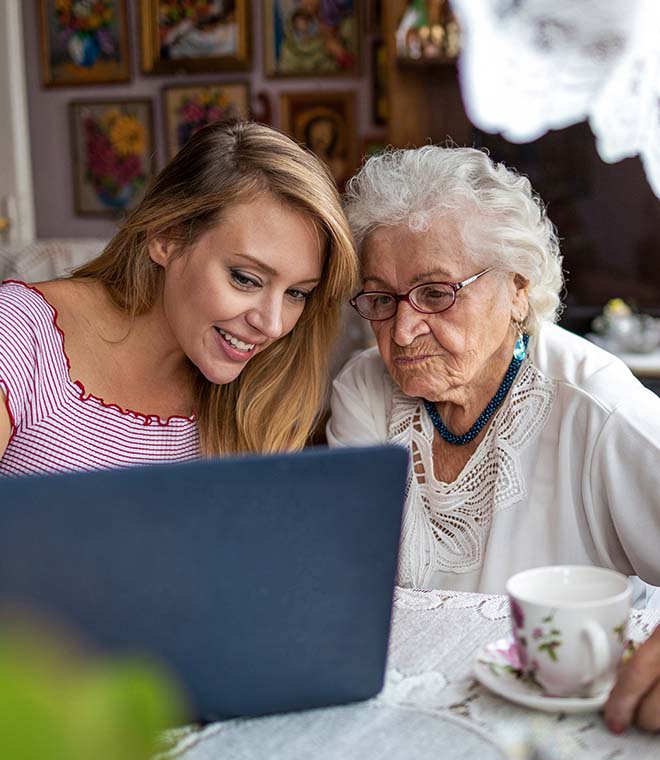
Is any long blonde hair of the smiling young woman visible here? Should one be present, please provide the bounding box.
[73,122,357,456]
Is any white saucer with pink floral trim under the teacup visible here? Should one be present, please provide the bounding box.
[474,636,611,713]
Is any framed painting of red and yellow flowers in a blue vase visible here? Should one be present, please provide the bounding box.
[69,99,154,216]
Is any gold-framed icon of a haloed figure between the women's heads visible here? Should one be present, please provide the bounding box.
[280,92,358,189]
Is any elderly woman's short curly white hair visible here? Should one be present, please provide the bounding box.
[344,145,563,334]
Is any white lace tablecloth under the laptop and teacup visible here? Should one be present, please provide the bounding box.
[160,589,660,760]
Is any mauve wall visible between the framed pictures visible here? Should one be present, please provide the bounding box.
[23,0,378,238]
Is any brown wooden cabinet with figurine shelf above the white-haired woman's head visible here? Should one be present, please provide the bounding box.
[383,0,471,148]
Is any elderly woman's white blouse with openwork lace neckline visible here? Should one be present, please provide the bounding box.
[327,324,660,594]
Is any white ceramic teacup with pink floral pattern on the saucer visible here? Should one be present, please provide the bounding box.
[506,565,631,697]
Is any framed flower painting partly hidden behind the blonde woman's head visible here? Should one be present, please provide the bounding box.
[163,82,250,160]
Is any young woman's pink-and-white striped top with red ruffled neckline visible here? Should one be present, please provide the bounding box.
[0,280,200,477]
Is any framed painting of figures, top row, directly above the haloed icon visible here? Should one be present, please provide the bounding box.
[264,0,360,77]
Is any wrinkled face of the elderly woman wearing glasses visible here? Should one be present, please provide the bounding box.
[362,217,527,402]
